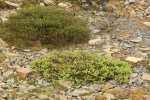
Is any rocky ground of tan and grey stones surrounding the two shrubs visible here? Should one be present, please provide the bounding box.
[0,0,150,100]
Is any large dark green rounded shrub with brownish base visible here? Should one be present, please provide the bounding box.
[0,7,90,46]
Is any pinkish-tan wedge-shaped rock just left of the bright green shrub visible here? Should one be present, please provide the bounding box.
[16,68,33,78]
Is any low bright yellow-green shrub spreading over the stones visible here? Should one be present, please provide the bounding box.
[31,51,131,84]
